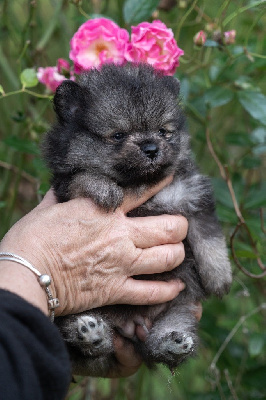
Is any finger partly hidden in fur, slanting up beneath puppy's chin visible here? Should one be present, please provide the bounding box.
[119,176,173,214]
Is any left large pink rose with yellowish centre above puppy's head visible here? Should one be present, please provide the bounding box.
[69,18,129,73]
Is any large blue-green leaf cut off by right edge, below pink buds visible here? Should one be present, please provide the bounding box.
[237,90,266,125]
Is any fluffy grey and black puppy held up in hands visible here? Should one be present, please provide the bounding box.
[44,64,232,376]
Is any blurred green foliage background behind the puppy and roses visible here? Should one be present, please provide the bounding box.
[0,0,266,400]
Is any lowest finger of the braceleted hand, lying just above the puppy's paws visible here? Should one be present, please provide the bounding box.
[115,278,185,305]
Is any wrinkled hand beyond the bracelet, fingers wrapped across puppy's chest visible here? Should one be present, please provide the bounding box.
[1,179,187,315]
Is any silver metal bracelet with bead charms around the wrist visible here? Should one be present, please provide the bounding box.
[0,252,59,322]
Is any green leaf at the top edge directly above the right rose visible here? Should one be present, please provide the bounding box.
[123,0,159,24]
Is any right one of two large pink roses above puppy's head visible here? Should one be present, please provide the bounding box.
[126,21,184,75]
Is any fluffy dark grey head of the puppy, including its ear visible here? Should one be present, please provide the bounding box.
[50,65,187,187]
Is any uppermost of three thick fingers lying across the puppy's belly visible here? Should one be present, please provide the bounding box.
[127,215,188,249]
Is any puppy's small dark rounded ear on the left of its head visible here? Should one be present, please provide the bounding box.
[54,80,84,122]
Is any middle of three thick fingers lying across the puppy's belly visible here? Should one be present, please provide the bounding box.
[130,243,185,276]
